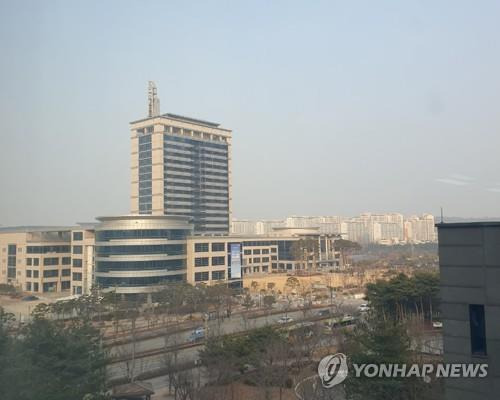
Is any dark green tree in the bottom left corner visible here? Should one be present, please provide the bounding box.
[0,314,106,400]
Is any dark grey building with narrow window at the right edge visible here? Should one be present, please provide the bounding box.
[437,222,500,400]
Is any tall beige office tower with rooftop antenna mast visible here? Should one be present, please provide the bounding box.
[131,84,232,235]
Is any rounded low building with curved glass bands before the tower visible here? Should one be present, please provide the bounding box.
[95,215,193,294]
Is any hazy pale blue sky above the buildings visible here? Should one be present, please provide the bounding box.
[0,0,500,225]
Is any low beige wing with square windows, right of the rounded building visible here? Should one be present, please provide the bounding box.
[187,228,342,285]
